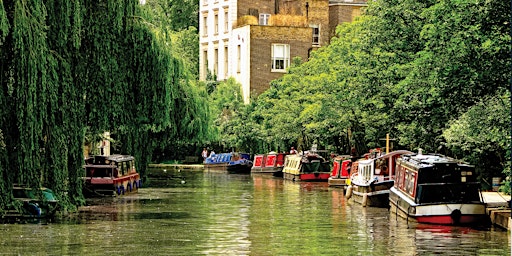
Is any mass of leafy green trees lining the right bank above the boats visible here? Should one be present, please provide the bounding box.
[230,0,511,194]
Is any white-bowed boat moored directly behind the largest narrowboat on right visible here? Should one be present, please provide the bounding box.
[346,149,412,207]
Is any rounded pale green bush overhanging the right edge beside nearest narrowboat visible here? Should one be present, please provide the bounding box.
[443,91,511,188]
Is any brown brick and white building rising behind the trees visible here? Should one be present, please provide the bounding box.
[199,0,366,103]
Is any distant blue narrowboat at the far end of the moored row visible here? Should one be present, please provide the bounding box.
[204,153,252,174]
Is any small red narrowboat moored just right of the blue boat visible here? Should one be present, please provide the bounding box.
[251,152,286,177]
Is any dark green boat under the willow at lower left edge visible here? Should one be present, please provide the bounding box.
[2,185,58,220]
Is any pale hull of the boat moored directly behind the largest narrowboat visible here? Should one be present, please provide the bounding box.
[347,180,394,208]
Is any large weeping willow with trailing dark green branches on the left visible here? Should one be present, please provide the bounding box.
[0,0,204,213]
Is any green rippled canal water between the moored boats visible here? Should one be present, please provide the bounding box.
[0,171,511,256]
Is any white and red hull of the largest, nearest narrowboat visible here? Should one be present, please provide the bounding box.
[389,188,488,225]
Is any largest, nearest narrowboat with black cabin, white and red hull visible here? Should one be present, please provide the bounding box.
[389,152,487,225]
